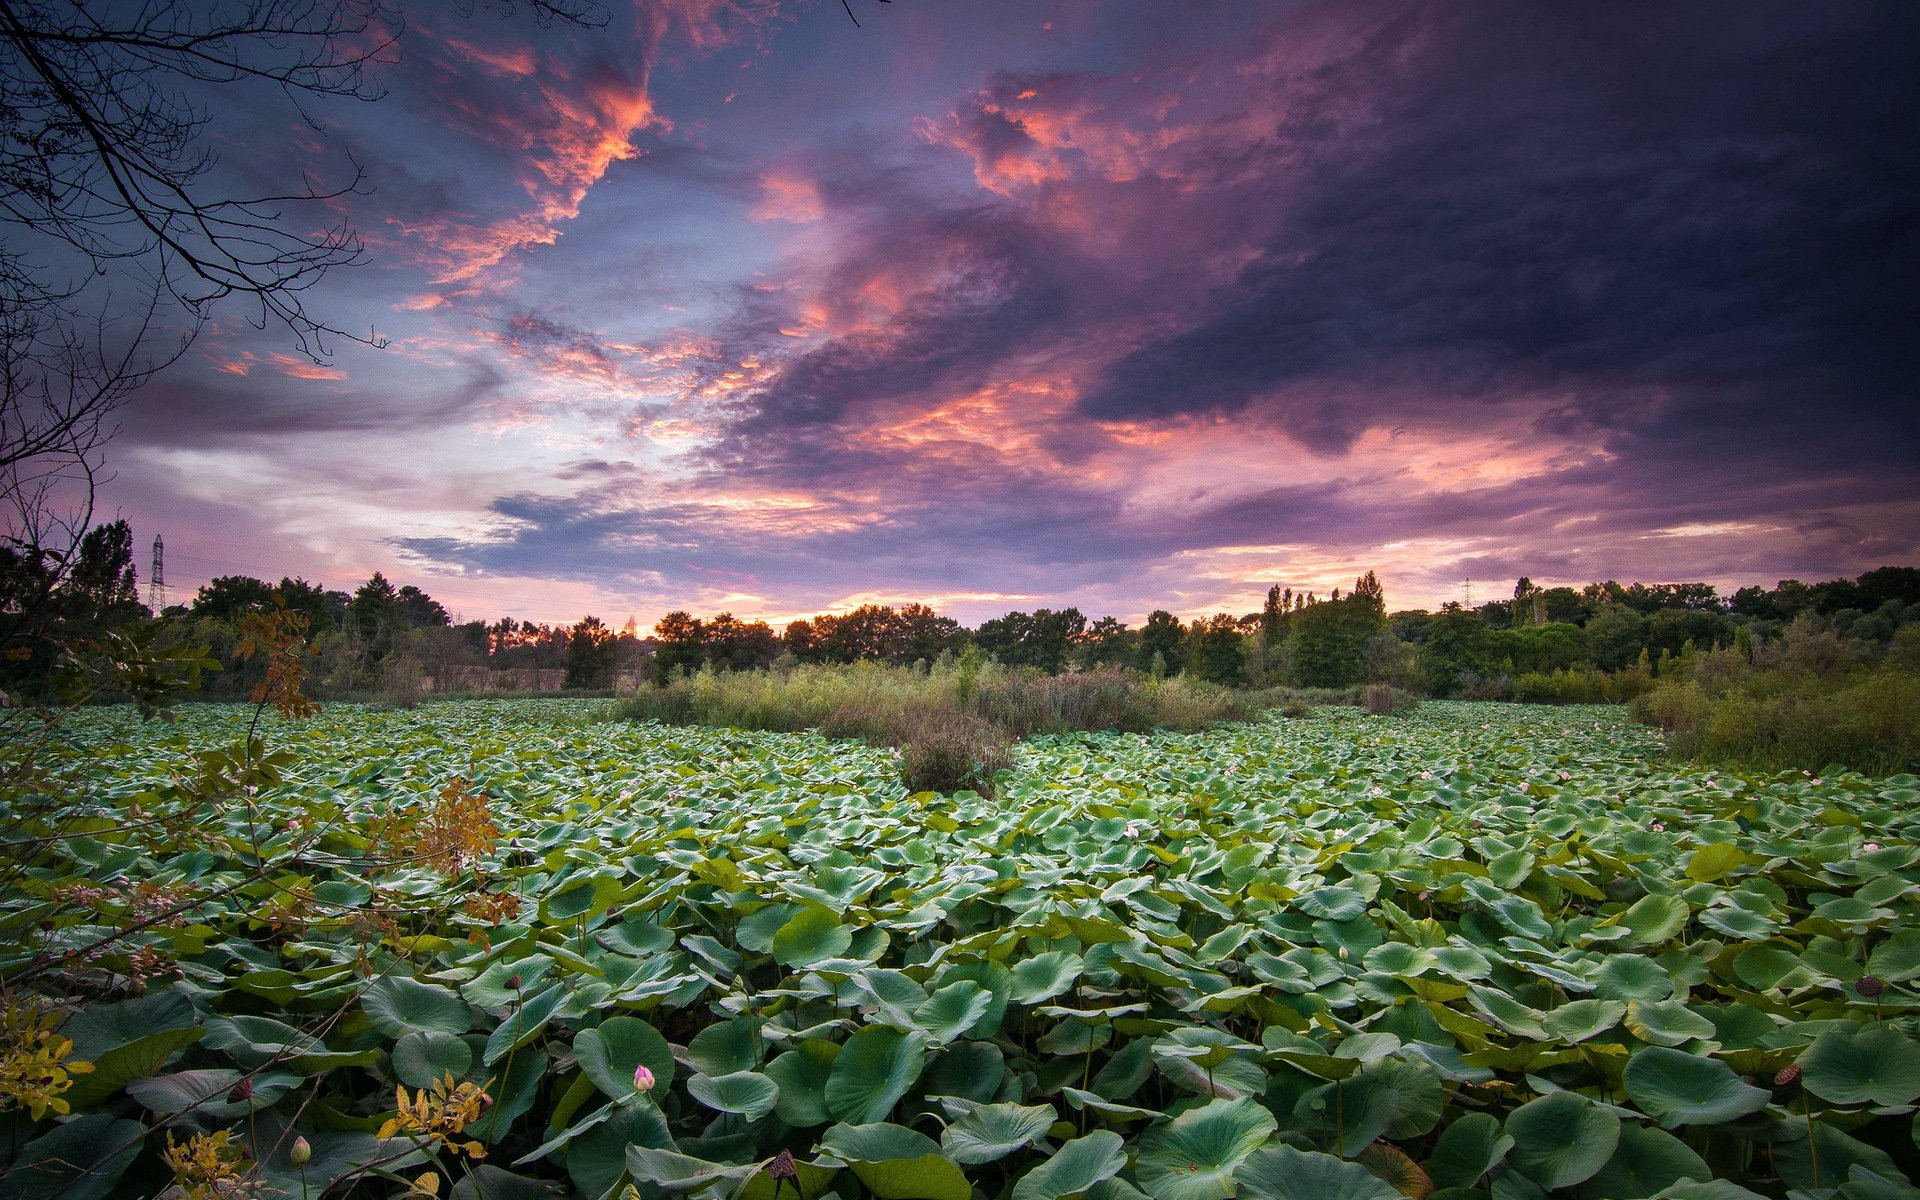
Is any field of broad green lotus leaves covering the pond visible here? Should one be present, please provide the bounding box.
[0,701,1920,1200]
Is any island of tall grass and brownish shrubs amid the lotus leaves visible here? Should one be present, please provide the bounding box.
[618,660,1267,795]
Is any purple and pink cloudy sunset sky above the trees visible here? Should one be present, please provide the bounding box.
[90,0,1920,628]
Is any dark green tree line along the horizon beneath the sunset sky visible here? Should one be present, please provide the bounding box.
[0,520,1920,699]
